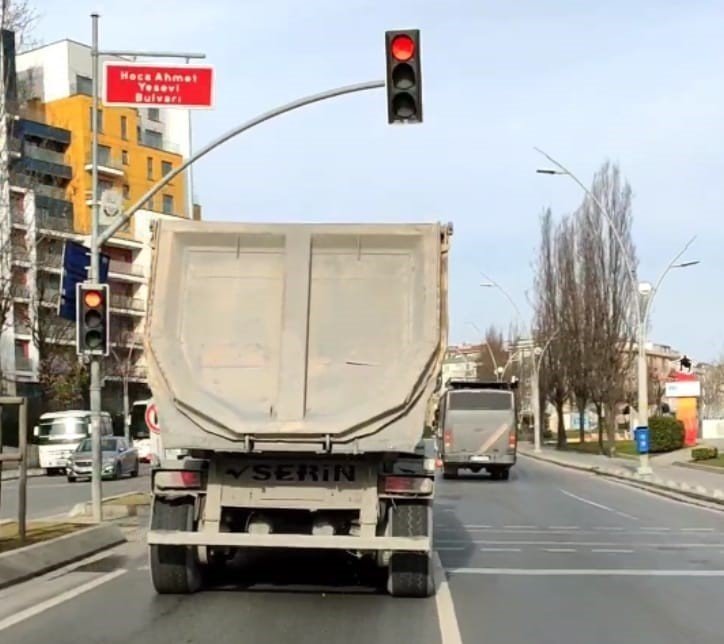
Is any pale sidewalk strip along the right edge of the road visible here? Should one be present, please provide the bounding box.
[518,442,724,505]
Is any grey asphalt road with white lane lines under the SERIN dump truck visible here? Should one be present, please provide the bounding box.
[0,459,724,644]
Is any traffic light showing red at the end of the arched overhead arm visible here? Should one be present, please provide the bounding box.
[385,29,422,123]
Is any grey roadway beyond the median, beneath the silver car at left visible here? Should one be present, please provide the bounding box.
[0,465,150,519]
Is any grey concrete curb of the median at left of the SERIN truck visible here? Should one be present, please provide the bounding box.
[0,524,126,589]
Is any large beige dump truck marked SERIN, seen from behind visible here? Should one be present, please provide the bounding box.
[144,220,452,597]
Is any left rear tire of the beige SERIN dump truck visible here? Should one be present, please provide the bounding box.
[150,498,202,595]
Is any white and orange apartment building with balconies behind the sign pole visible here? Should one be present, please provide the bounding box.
[0,32,200,410]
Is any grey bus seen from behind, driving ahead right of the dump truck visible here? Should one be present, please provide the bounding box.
[438,379,518,481]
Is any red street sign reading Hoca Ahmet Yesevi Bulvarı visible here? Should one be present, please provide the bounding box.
[103,61,214,109]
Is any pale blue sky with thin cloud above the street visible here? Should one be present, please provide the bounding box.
[25,0,724,361]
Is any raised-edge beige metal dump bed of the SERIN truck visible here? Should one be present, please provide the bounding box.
[145,220,449,453]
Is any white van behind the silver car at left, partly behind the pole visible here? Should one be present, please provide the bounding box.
[33,409,113,474]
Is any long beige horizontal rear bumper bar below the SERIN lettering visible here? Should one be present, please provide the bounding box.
[147,530,432,552]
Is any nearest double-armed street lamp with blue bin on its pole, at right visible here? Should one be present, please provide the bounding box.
[534,148,699,476]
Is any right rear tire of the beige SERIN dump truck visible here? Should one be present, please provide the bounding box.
[387,504,435,597]
